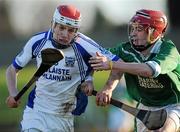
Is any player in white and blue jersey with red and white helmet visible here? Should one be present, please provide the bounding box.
[6,5,118,132]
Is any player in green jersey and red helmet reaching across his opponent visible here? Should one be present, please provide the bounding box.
[89,9,180,132]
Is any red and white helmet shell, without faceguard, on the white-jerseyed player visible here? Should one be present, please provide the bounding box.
[53,5,81,28]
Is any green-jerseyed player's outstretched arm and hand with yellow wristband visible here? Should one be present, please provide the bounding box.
[89,54,154,77]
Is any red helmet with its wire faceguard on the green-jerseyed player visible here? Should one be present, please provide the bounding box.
[128,9,167,49]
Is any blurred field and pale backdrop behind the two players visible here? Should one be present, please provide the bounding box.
[0,0,180,132]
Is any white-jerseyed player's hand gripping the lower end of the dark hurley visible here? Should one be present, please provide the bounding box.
[6,96,20,108]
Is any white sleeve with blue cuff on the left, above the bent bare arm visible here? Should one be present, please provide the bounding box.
[13,39,33,70]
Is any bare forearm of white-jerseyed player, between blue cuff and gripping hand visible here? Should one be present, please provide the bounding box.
[6,65,18,96]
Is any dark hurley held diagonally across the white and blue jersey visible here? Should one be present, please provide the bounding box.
[14,48,64,101]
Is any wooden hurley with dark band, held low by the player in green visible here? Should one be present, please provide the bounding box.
[92,90,167,130]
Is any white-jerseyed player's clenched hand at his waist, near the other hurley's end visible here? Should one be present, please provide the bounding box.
[81,81,94,96]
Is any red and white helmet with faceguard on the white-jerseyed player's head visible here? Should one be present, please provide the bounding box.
[51,5,81,49]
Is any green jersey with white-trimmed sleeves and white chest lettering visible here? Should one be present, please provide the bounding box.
[109,40,180,106]
